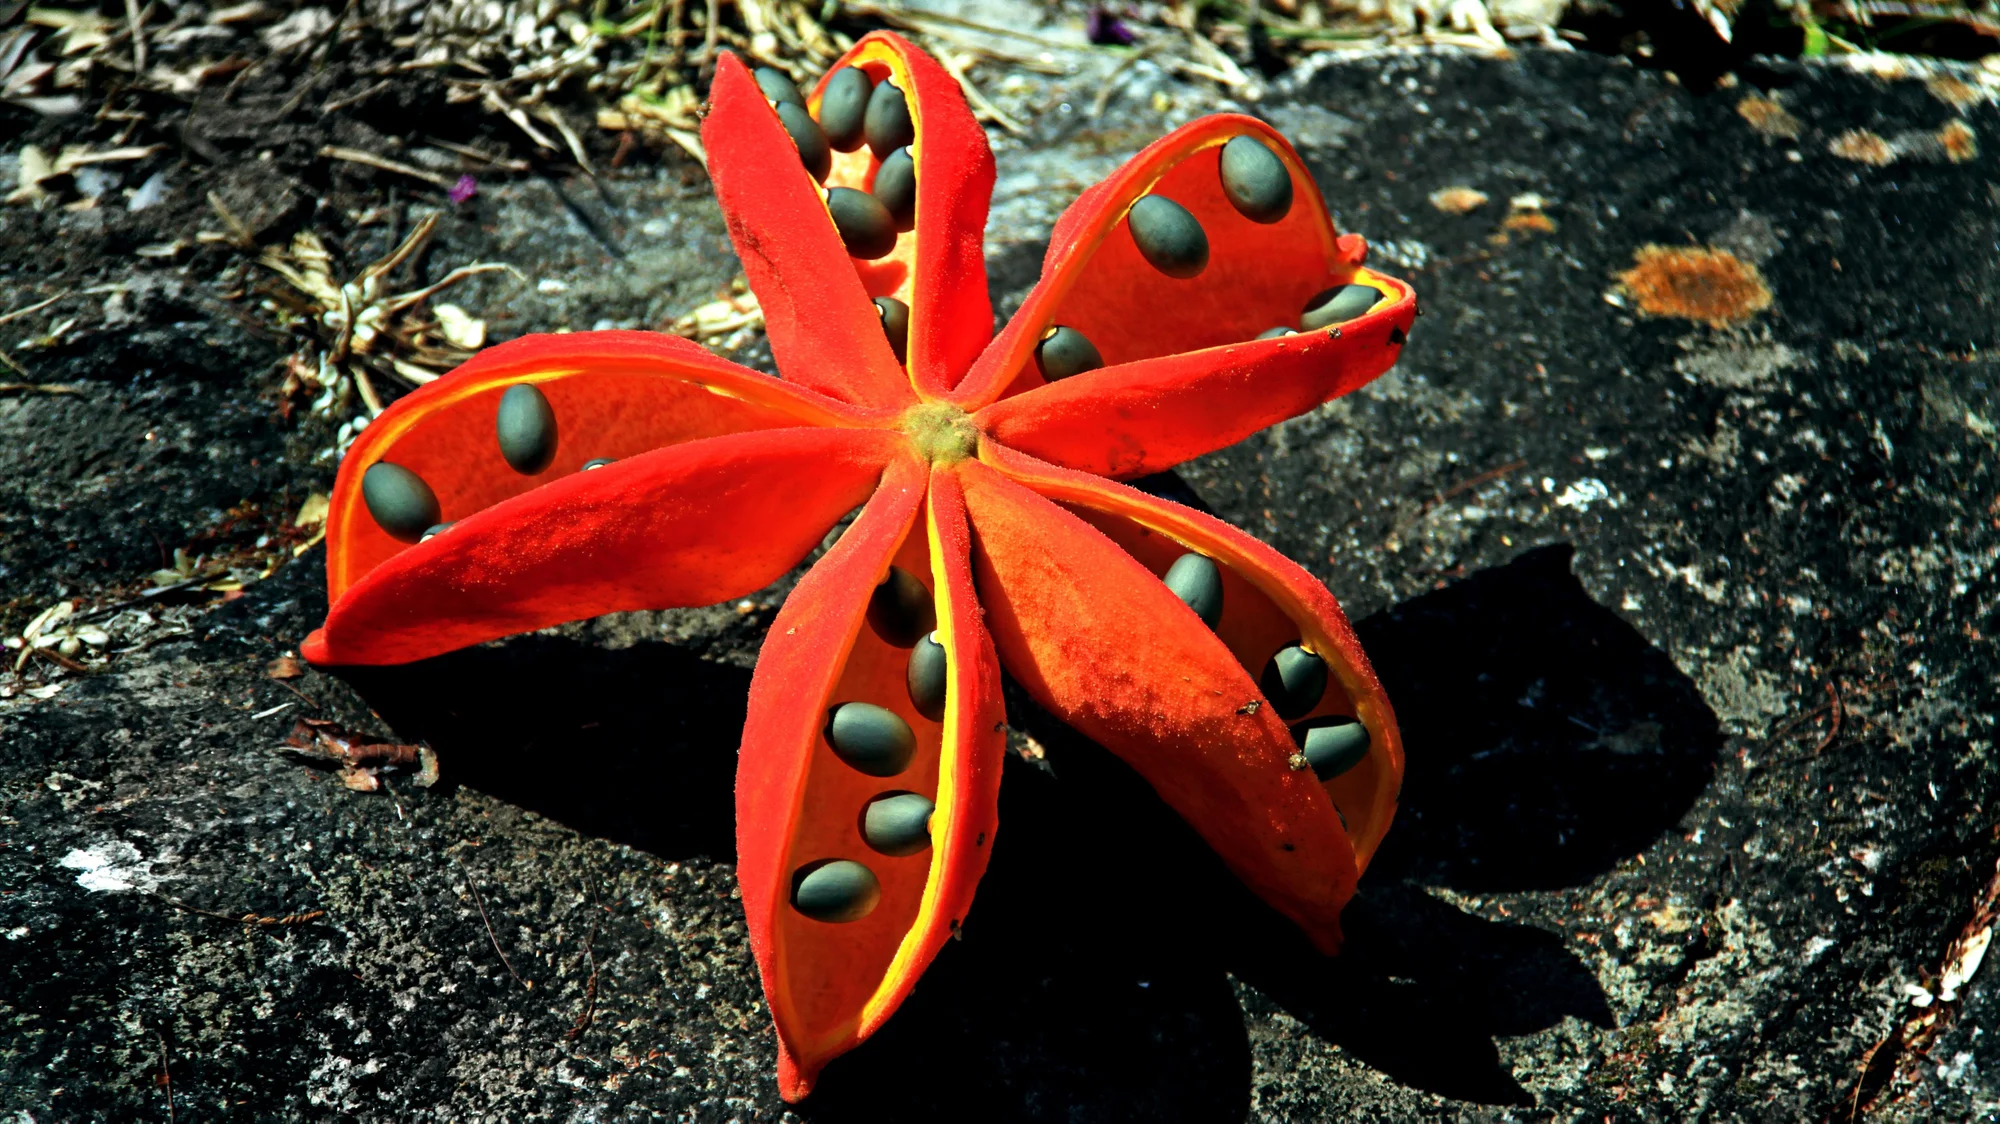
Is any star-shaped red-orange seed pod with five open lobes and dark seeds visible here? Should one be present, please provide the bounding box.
[302,32,1416,1100]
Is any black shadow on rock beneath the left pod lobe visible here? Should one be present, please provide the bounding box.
[340,636,750,860]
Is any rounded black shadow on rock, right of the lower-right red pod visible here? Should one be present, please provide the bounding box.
[1356,546,1722,892]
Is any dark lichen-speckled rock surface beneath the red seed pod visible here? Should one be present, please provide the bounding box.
[0,46,2000,1122]
